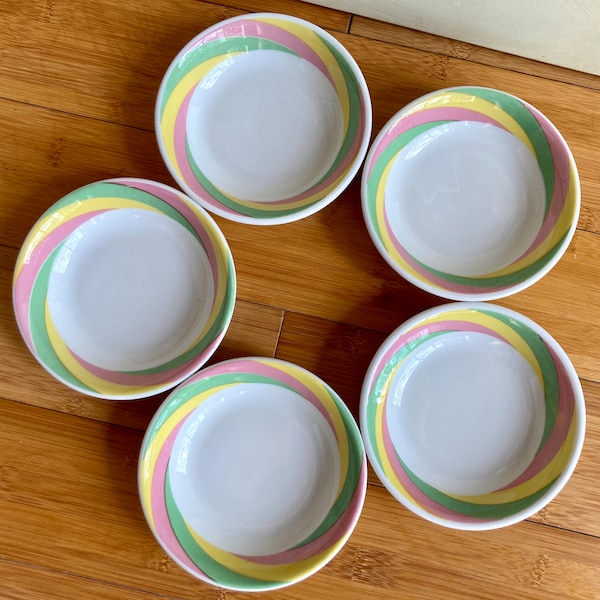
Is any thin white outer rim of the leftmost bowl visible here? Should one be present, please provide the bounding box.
[11,177,237,401]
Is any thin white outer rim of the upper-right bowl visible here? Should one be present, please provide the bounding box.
[361,85,581,302]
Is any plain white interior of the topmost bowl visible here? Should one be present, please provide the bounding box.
[186,49,344,202]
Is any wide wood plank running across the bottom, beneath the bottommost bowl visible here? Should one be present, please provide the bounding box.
[0,400,600,600]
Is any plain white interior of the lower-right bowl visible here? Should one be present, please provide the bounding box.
[386,331,546,496]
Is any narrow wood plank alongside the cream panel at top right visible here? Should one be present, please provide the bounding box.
[348,15,600,90]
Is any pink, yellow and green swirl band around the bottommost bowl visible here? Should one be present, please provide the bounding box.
[139,358,367,590]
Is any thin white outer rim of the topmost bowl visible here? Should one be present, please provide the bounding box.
[154,12,373,225]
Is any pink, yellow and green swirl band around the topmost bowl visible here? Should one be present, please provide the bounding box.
[157,16,370,218]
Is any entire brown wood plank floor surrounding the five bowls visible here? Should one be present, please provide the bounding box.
[0,0,600,600]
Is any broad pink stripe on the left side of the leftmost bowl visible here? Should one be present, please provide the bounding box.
[13,210,106,349]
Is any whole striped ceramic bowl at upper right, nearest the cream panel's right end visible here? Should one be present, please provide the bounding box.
[362,87,580,300]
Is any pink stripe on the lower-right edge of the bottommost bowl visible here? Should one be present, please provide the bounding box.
[239,460,367,565]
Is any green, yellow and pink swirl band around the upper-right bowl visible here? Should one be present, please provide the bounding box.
[365,88,579,294]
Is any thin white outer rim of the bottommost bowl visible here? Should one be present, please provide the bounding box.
[137,355,368,592]
